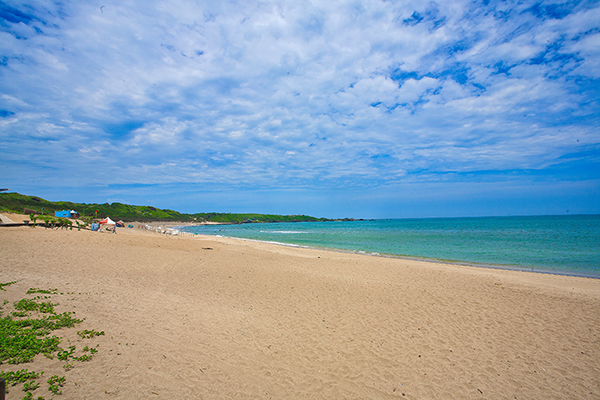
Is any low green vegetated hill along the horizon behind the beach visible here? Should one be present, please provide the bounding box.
[0,193,329,224]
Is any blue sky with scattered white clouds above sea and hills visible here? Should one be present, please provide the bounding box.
[0,0,600,218]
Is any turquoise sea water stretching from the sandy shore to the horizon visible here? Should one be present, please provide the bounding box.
[182,215,600,278]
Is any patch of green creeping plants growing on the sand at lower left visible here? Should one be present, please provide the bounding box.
[0,282,104,400]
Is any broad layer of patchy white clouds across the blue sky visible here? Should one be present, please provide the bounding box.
[0,0,600,202]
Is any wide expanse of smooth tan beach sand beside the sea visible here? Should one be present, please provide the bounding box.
[0,226,600,400]
